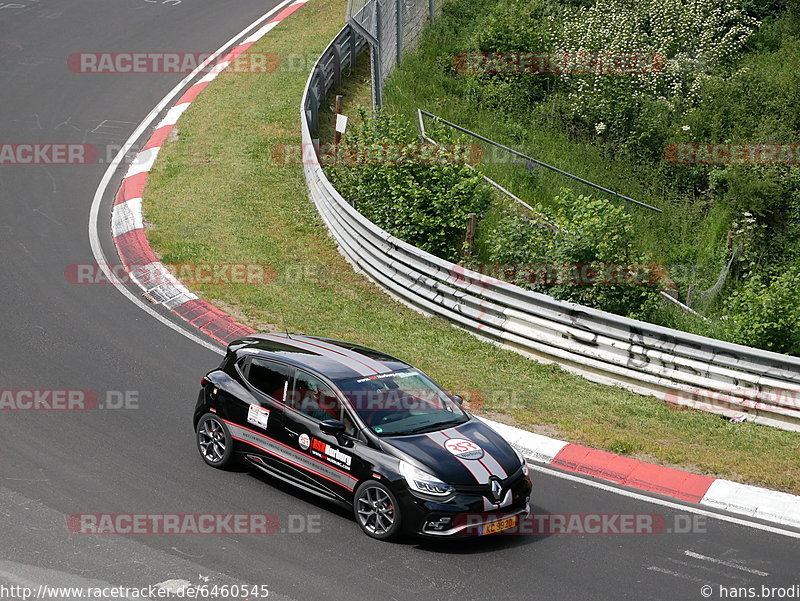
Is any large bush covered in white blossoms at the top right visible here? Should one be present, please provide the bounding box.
[555,0,758,157]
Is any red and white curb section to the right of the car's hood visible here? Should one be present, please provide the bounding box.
[481,418,800,528]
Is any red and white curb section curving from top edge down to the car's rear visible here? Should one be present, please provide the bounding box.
[111,0,309,344]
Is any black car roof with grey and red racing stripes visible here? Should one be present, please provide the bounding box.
[228,334,411,381]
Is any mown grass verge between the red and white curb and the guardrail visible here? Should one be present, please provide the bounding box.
[144,0,800,492]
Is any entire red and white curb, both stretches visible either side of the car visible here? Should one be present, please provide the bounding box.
[104,0,800,528]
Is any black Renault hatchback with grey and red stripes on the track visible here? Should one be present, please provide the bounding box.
[194,334,532,540]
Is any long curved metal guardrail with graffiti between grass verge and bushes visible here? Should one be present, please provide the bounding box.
[301,25,800,431]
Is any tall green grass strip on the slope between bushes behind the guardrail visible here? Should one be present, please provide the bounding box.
[376,0,790,341]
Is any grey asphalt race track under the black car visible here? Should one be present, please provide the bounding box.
[0,0,800,601]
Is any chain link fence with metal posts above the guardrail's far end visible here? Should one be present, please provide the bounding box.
[347,0,444,108]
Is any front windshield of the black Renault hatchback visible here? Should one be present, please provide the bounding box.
[338,369,469,436]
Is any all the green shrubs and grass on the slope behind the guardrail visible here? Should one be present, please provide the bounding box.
[340,0,800,354]
